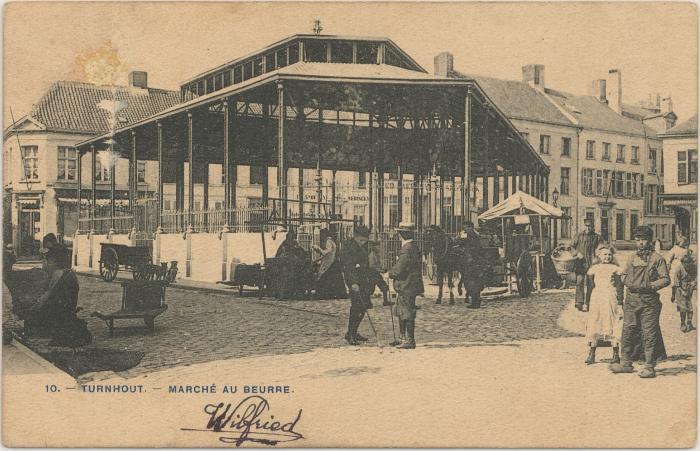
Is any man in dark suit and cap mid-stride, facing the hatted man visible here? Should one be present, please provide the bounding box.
[340,225,374,345]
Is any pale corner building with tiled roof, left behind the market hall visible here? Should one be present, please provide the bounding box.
[3,72,180,256]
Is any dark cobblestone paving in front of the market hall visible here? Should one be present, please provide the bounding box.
[6,270,575,377]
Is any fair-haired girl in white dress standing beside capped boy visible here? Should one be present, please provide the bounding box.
[586,244,623,365]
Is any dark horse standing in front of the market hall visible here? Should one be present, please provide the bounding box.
[424,225,464,305]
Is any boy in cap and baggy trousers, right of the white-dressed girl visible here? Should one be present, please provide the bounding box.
[610,225,671,379]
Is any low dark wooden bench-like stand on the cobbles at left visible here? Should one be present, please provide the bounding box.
[92,280,168,337]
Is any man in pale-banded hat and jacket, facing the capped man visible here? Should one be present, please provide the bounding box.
[389,223,424,349]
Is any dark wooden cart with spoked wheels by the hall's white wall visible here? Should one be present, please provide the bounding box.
[100,243,177,283]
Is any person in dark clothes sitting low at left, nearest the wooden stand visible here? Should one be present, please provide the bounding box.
[13,242,92,347]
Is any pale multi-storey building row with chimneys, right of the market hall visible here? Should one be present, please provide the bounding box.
[435,52,676,247]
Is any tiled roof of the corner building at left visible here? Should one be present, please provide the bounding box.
[29,81,180,133]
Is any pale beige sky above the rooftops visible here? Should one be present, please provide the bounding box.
[3,2,698,127]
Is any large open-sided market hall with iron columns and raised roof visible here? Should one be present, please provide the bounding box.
[73,35,549,282]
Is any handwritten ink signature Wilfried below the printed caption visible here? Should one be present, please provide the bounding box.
[182,395,304,446]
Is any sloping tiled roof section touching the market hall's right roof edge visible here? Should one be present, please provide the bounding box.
[454,71,573,126]
